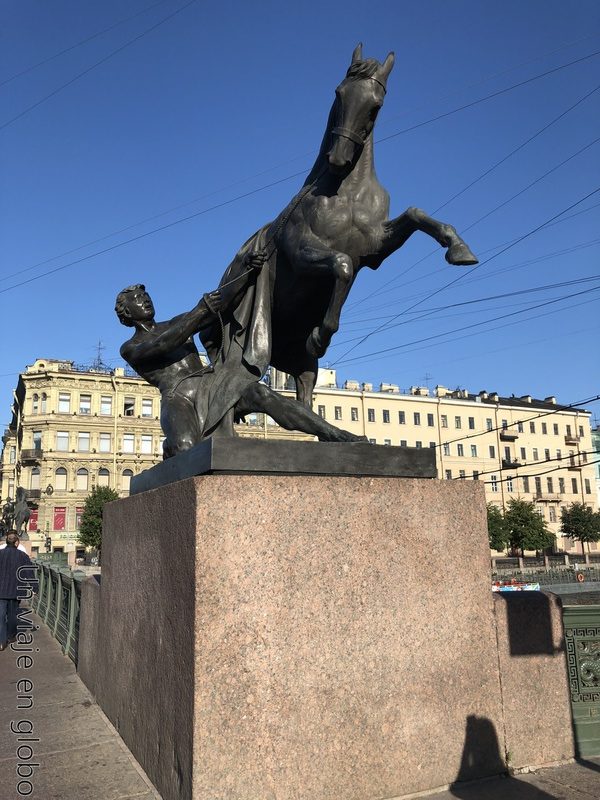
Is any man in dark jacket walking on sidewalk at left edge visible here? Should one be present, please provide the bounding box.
[0,531,37,651]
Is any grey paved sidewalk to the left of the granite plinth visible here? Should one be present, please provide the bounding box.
[0,615,160,800]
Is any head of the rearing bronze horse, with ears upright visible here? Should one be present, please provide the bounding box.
[327,44,394,174]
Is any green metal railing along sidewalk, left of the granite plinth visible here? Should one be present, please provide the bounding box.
[32,561,86,664]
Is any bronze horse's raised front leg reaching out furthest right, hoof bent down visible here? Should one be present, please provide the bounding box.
[377,207,479,266]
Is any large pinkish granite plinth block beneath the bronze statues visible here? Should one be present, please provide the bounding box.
[90,475,504,800]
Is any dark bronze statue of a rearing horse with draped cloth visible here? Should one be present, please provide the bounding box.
[200,44,477,432]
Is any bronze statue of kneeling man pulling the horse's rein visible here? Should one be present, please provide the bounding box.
[115,253,363,458]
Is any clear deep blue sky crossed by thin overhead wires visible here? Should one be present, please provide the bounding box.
[0,0,600,424]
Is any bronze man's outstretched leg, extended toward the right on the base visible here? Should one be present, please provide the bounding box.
[236,383,365,442]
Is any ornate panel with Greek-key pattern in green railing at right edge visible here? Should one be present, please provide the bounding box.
[565,624,600,703]
